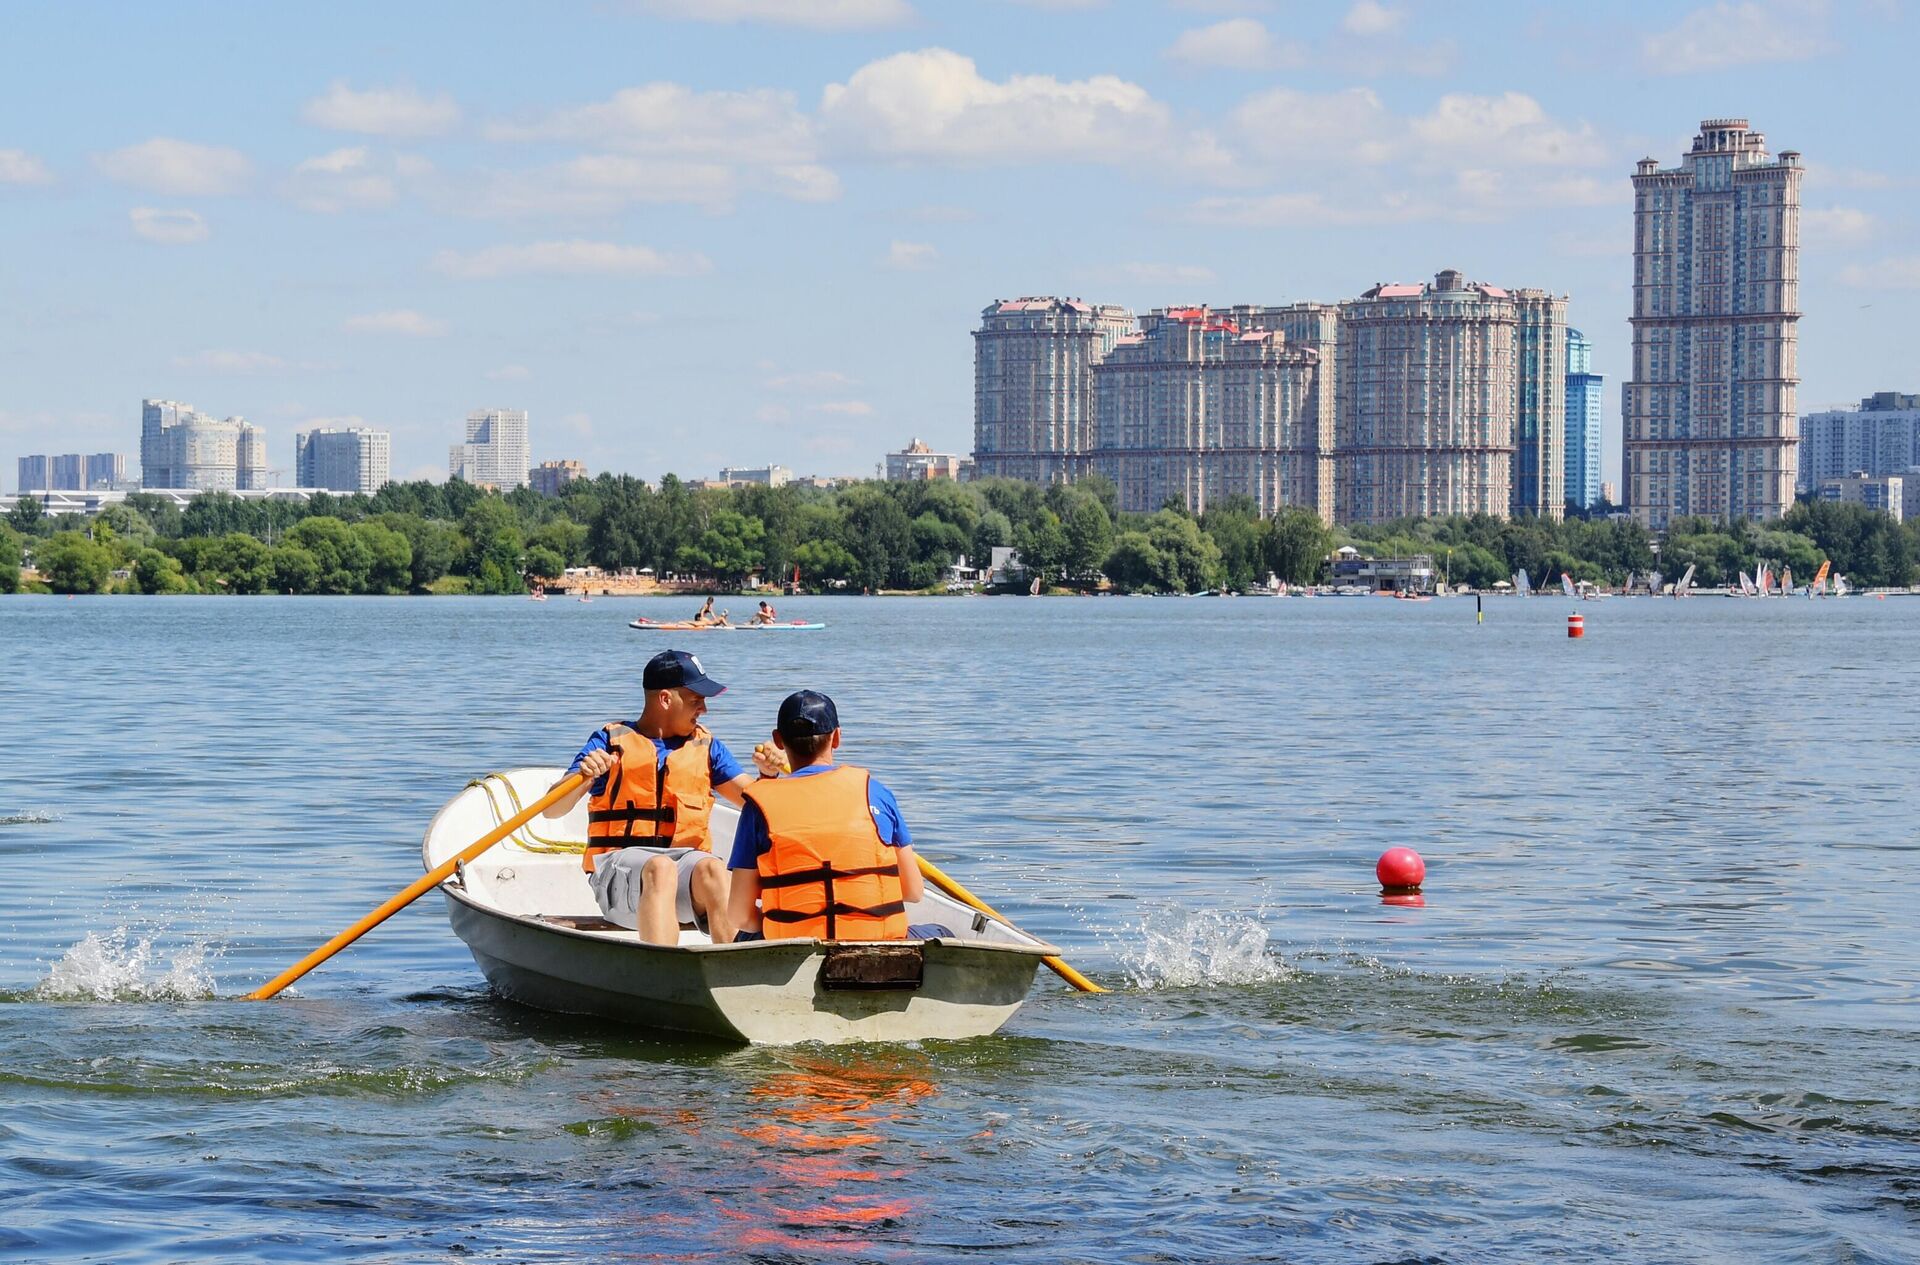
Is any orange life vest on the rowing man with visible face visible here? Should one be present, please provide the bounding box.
[580,722,714,871]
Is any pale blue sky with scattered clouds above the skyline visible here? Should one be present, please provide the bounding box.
[0,0,1920,488]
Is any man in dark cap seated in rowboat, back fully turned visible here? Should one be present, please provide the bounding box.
[730,689,952,941]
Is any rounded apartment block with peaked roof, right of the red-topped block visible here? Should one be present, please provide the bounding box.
[1334,269,1528,522]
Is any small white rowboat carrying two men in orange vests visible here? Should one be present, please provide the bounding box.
[420,768,1060,1044]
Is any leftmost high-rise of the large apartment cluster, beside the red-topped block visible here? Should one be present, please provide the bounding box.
[973,298,1133,484]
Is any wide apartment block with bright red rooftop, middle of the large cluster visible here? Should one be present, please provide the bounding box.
[1092,307,1319,514]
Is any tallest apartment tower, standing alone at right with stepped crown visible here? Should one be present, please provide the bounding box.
[1620,119,1801,530]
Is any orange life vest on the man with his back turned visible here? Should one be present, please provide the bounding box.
[747,764,906,941]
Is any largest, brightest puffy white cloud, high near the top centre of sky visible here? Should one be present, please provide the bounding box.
[820,48,1171,163]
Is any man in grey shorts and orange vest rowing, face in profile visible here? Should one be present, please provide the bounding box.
[545,651,778,944]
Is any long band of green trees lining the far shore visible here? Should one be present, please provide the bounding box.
[0,474,1920,593]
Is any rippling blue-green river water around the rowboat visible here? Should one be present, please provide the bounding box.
[0,597,1920,1263]
